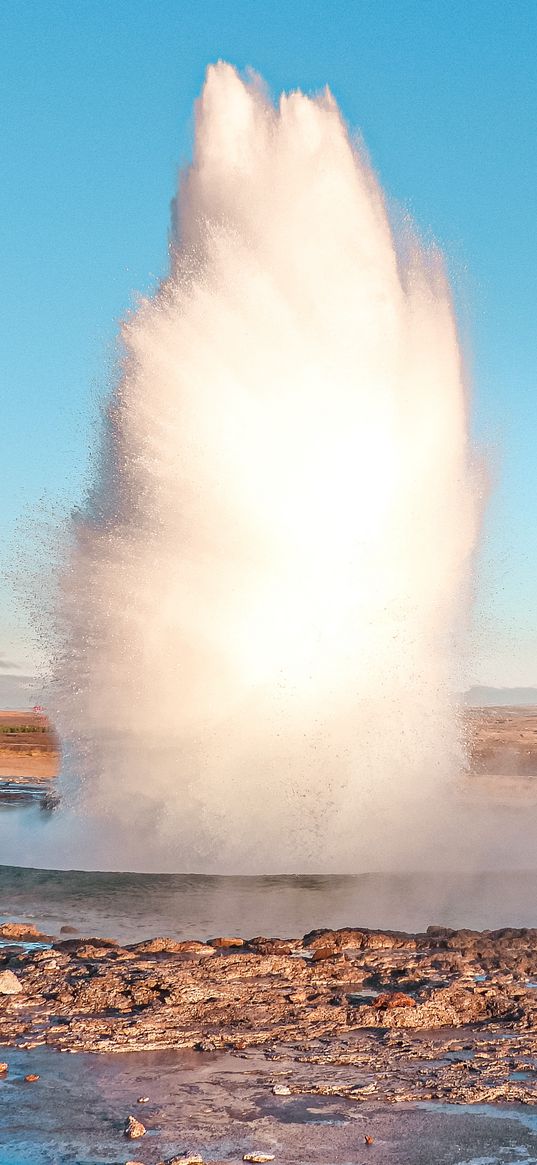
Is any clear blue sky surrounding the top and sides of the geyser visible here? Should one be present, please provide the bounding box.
[0,0,537,686]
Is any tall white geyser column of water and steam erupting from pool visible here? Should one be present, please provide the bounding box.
[49,63,479,873]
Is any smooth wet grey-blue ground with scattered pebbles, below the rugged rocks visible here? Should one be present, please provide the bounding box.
[0,1049,537,1165]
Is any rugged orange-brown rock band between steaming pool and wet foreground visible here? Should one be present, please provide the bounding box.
[0,927,537,1067]
